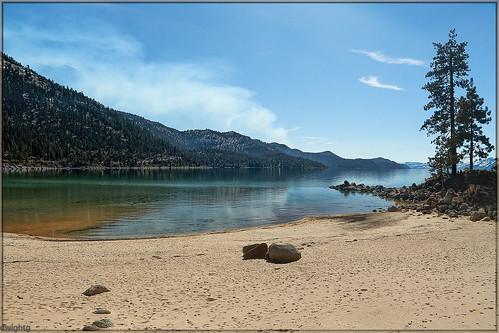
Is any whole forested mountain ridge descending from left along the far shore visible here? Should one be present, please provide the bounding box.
[2,55,407,169]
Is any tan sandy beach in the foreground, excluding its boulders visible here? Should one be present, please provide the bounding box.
[3,212,496,331]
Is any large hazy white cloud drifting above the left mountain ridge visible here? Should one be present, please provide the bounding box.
[4,25,295,143]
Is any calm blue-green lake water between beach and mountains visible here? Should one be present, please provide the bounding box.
[3,169,428,239]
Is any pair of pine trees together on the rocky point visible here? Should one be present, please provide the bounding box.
[421,30,494,176]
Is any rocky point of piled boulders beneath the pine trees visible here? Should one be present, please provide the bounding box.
[330,172,497,221]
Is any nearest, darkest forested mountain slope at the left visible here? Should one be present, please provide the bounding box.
[2,56,196,167]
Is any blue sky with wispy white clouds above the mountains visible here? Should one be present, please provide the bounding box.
[3,3,496,162]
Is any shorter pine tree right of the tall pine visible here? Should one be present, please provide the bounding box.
[457,79,494,170]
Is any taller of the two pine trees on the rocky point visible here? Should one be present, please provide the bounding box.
[421,29,469,175]
